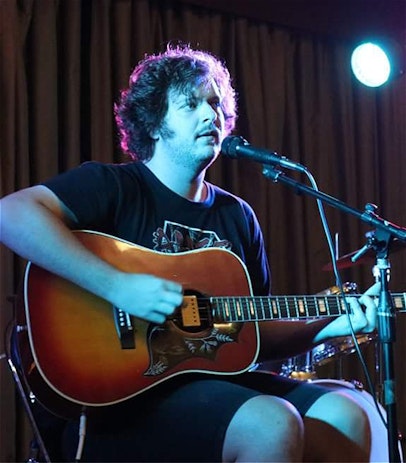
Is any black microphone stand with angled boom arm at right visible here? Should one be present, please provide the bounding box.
[262,164,406,463]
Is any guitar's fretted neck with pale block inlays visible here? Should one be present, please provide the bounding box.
[209,293,406,323]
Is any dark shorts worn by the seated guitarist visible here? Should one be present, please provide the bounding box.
[59,372,330,462]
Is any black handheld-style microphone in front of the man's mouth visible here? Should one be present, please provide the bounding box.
[221,135,307,176]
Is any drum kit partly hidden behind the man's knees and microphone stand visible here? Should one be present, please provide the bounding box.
[255,244,404,462]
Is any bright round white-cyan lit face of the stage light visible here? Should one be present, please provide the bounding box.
[351,42,392,87]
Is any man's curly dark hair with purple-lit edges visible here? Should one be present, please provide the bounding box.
[114,45,237,161]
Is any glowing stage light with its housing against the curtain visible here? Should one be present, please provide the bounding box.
[351,41,403,87]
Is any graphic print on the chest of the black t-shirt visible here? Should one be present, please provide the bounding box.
[153,220,231,253]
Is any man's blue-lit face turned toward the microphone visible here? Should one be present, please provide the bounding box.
[156,80,226,167]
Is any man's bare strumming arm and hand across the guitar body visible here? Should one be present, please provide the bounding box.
[0,186,182,323]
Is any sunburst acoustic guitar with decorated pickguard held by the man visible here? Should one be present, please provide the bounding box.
[17,231,406,415]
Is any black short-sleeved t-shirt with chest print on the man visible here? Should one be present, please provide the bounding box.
[44,162,270,295]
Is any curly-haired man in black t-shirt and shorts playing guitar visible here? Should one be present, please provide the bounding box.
[1,46,375,462]
